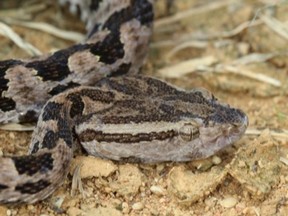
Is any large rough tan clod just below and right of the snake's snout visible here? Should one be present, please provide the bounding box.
[228,138,281,199]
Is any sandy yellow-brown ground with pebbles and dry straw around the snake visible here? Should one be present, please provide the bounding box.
[0,0,288,216]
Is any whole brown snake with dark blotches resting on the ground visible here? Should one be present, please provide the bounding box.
[0,0,248,204]
